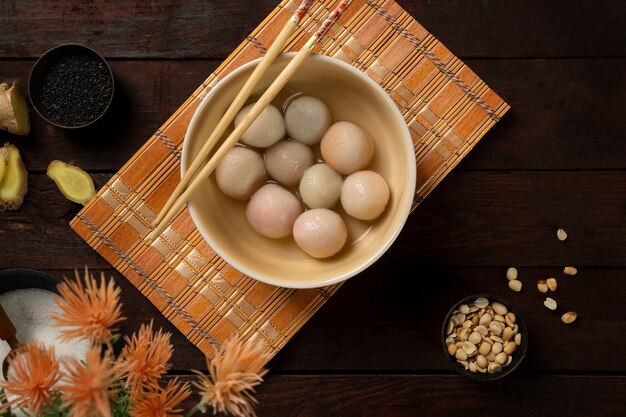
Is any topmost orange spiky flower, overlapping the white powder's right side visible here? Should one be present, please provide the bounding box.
[51,268,124,347]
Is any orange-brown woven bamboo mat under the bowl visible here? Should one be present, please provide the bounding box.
[71,0,509,357]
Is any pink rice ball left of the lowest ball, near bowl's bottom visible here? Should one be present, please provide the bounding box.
[246,183,302,239]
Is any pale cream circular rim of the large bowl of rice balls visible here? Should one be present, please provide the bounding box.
[180,52,417,289]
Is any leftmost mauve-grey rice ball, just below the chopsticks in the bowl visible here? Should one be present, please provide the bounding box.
[215,146,267,200]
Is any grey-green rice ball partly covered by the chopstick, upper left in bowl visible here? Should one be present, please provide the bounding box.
[235,103,285,148]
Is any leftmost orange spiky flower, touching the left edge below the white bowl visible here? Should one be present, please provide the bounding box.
[0,342,61,415]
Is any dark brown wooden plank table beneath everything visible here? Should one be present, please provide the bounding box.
[0,0,626,417]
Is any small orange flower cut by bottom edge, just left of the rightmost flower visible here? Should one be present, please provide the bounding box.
[131,379,191,417]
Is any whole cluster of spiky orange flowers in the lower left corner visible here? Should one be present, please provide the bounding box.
[0,269,268,417]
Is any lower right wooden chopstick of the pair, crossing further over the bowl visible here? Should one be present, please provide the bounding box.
[148,0,351,240]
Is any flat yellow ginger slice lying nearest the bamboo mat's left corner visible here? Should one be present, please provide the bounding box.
[46,161,96,205]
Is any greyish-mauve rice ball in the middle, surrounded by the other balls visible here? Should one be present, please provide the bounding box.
[265,140,314,187]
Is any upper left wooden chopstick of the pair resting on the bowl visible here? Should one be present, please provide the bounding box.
[153,0,313,231]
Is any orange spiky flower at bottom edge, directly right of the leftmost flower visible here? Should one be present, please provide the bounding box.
[58,348,118,417]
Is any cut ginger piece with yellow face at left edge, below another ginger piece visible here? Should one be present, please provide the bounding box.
[0,143,28,210]
